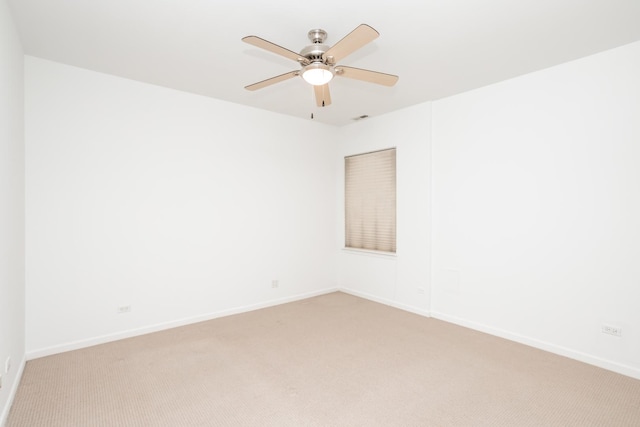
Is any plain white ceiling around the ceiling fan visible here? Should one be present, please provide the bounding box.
[9,0,640,125]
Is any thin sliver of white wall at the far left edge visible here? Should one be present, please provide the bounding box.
[0,0,25,425]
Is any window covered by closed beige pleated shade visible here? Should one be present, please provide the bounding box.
[344,148,396,253]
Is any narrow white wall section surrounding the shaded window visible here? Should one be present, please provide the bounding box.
[336,103,431,315]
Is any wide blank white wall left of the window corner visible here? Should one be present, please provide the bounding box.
[25,57,337,357]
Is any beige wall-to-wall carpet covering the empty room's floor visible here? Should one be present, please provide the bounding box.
[8,292,640,427]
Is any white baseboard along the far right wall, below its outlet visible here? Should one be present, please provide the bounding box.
[431,312,640,379]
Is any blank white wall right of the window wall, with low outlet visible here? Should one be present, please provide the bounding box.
[432,43,640,377]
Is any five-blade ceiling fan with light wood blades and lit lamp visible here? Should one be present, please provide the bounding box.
[242,24,398,107]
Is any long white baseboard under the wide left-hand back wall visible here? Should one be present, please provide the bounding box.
[28,288,339,362]
